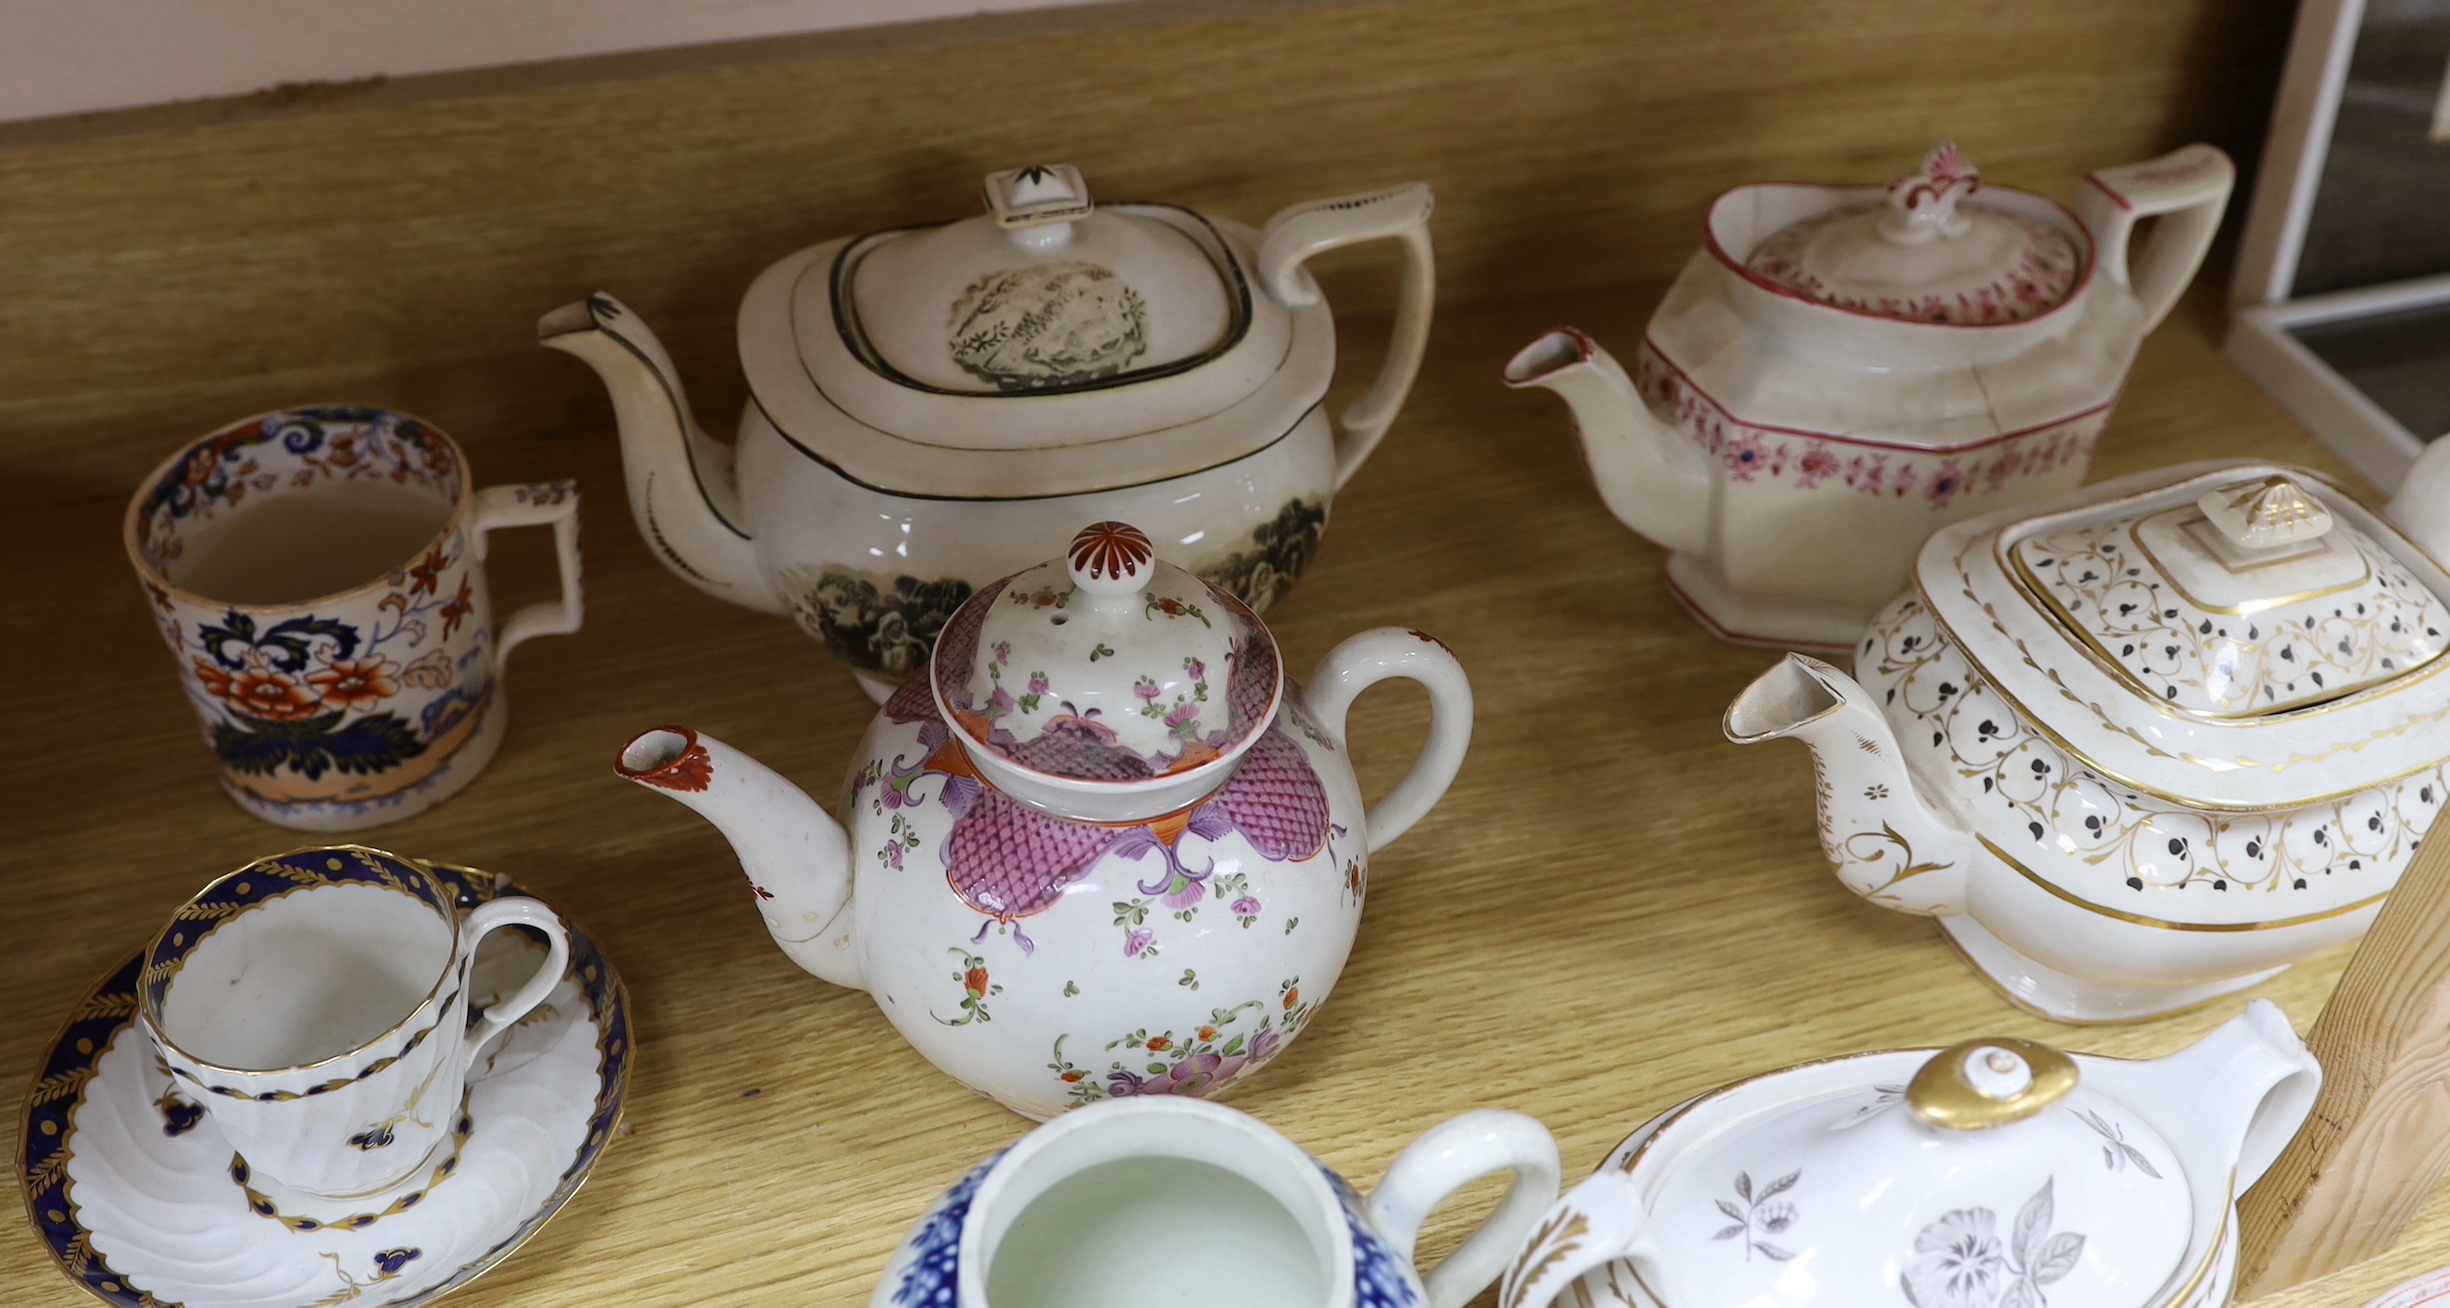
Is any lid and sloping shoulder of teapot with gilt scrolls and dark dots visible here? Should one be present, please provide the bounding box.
[1913,460,2450,808]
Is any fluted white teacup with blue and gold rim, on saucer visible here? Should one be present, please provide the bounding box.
[137,845,568,1205]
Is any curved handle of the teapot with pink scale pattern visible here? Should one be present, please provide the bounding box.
[1301,627,1472,855]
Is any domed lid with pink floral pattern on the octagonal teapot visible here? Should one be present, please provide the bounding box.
[1744,145,2083,326]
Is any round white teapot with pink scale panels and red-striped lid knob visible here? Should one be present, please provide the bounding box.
[617,522,1472,1119]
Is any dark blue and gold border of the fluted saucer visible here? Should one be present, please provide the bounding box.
[15,855,637,1308]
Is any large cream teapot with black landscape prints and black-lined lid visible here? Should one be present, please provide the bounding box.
[537,167,1433,703]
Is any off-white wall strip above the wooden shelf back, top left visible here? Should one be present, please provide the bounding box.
[0,0,1117,122]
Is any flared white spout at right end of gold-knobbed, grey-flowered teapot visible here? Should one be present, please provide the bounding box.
[2085,999,2323,1193]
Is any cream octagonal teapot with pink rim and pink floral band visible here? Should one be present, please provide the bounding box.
[1507,145,2237,652]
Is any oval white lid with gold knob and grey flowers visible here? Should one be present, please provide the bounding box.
[1624,1036,2195,1308]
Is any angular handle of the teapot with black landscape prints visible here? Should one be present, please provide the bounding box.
[1259,181,1438,490]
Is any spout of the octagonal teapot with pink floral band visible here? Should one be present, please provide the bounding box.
[1507,328,1715,554]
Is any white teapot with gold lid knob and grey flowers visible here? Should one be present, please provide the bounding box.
[1499,999,2323,1308]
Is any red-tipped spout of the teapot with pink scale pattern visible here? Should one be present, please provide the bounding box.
[613,727,865,990]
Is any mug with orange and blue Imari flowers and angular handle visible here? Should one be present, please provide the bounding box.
[125,407,583,830]
